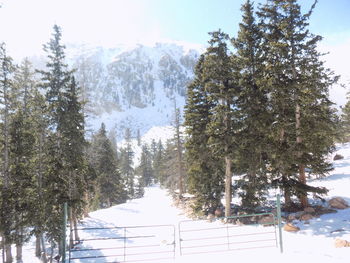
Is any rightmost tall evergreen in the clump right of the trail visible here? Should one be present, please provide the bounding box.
[259,0,336,207]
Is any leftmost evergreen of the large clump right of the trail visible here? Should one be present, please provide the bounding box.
[185,55,224,213]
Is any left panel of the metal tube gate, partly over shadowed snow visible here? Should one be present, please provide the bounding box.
[69,225,175,263]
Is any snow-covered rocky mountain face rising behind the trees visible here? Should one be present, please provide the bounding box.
[67,43,201,138]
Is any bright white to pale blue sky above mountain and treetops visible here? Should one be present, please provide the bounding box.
[0,0,350,104]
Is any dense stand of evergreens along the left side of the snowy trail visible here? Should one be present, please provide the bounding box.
[0,25,165,263]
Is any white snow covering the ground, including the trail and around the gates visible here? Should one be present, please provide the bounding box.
[5,143,350,263]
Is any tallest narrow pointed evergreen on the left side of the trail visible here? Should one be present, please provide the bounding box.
[39,25,72,244]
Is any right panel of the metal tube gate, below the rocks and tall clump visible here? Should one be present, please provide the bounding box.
[179,213,282,255]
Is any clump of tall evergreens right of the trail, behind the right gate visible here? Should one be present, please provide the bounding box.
[184,0,340,219]
